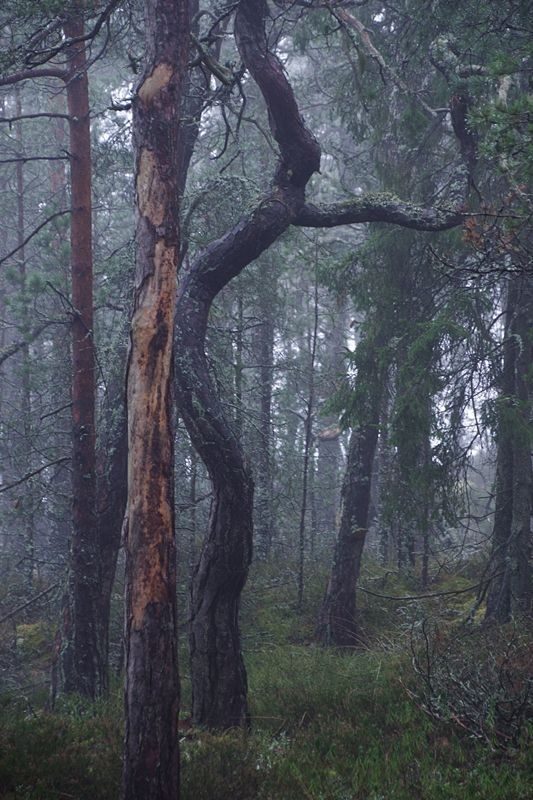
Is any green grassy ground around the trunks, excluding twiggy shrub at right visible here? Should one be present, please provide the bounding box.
[0,568,533,800]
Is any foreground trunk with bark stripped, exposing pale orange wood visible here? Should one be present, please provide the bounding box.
[123,0,189,800]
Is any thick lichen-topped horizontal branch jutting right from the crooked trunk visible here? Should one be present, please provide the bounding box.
[293,192,468,231]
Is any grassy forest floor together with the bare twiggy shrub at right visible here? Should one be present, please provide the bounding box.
[0,565,533,800]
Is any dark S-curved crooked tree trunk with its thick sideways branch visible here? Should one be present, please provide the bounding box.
[176,0,463,727]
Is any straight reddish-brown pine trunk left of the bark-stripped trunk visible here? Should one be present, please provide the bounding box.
[61,10,107,697]
